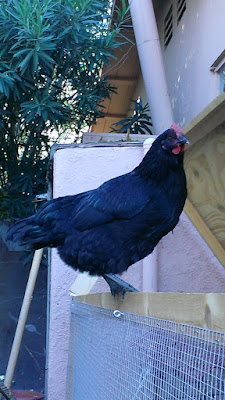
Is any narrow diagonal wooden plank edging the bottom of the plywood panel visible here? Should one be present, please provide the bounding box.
[184,198,225,267]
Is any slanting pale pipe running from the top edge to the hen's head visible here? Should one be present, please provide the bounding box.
[129,0,174,135]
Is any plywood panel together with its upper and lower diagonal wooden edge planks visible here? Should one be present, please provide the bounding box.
[184,93,225,267]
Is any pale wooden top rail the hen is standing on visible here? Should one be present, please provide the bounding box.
[73,293,225,332]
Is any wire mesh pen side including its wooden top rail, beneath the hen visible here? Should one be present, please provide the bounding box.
[67,293,225,400]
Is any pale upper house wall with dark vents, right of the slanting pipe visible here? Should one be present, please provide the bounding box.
[156,0,225,126]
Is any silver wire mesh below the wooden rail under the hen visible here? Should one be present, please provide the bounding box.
[67,301,225,400]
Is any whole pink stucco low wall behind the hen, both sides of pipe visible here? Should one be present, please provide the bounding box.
[46,145,225,400]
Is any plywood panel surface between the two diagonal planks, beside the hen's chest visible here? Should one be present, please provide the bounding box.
[185,125,225,249]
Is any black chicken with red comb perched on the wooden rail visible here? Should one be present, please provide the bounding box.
[8,124,188,296]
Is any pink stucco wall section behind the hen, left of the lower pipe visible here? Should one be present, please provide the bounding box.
[47,145,143,400]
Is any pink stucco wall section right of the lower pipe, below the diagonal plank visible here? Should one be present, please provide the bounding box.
[157,213,225,293]
